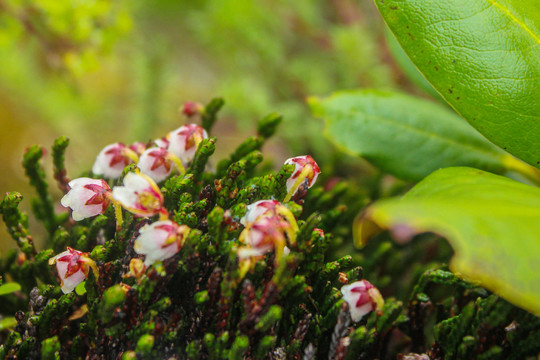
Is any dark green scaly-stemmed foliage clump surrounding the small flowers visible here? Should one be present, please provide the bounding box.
[0,100,540,359]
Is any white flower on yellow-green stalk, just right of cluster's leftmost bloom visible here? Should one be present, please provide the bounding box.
[112,172,167,217]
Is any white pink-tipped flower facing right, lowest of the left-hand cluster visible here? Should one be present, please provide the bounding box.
[134,220,190,266]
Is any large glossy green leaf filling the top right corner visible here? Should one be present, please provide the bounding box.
[375,0,540,168]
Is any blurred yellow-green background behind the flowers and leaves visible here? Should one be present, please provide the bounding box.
[0,0,426,250]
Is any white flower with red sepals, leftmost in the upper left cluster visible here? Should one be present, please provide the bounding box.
[60,178,111,221]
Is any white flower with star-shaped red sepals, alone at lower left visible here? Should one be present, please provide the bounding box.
[49,247,98,294]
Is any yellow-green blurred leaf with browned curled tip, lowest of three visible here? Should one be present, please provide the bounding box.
[354,167,540,316]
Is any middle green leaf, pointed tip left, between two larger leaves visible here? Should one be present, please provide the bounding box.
[309,90,528,181]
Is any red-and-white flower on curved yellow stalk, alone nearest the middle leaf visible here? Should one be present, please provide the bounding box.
[284,155,321,202]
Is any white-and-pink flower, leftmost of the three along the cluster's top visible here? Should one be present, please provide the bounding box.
[92,143,138,179]
